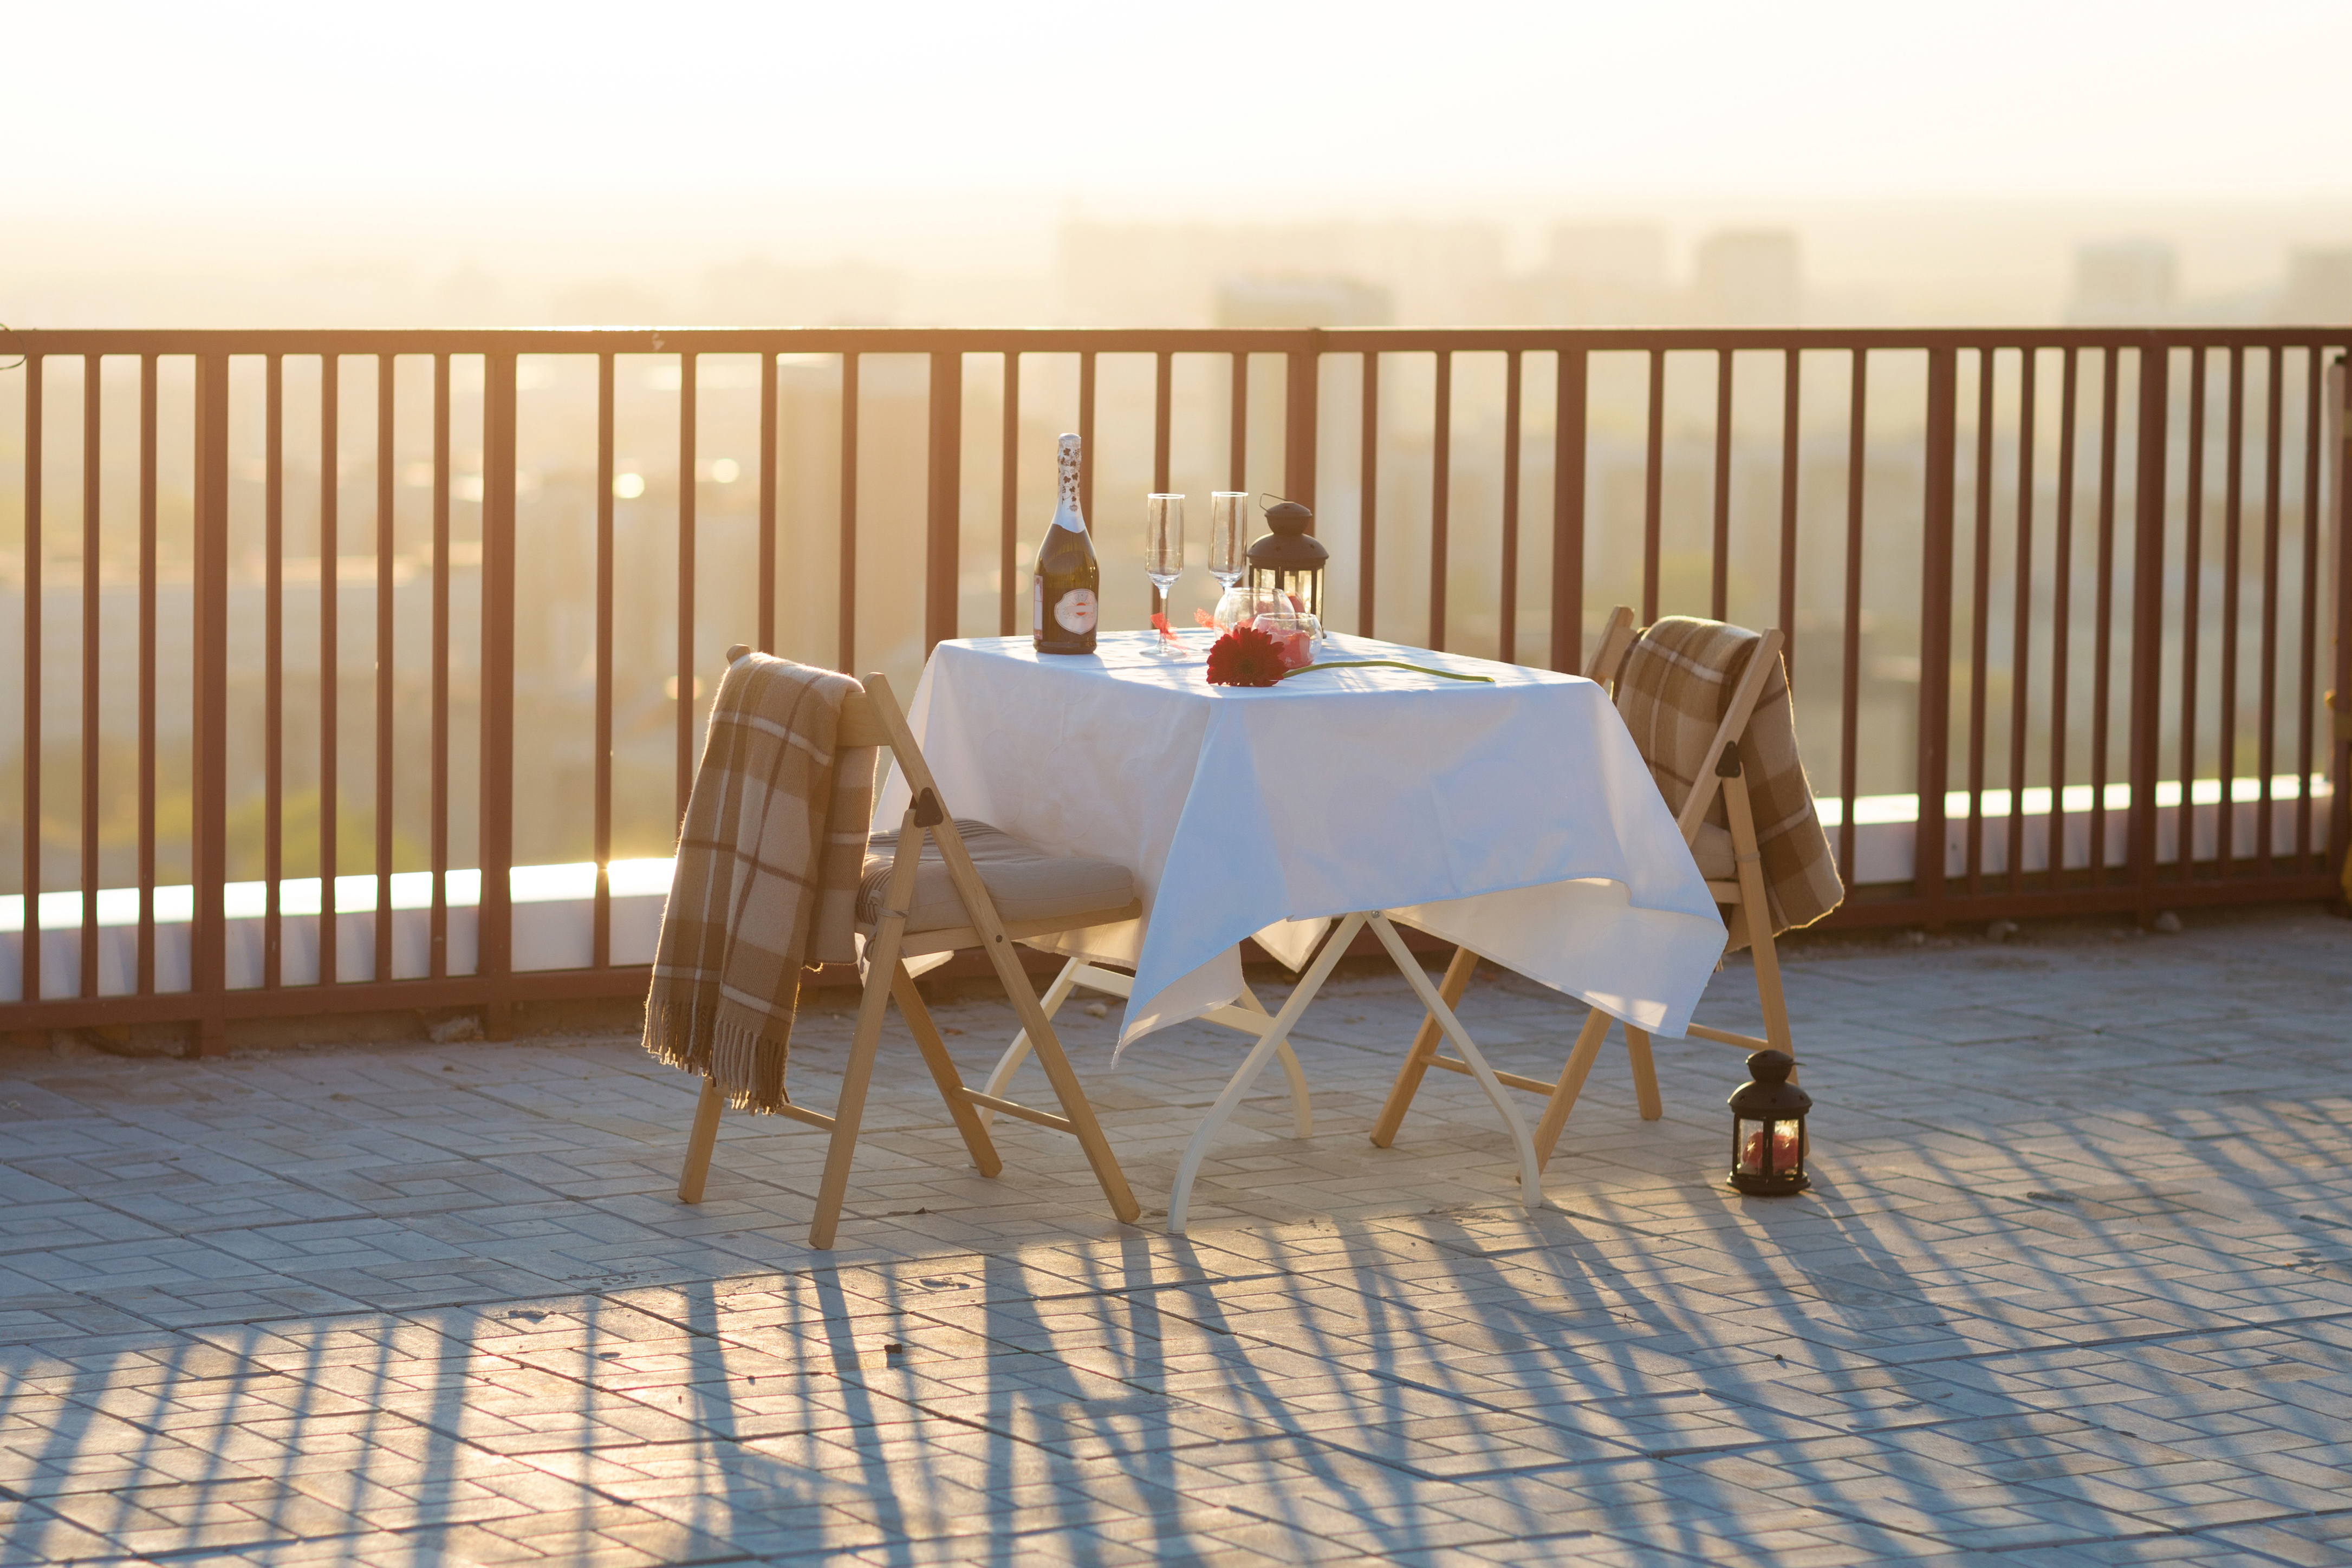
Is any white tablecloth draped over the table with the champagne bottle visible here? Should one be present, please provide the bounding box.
[875,630,1724,1051]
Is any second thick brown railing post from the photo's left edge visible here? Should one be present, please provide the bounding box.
[475,350,517,1039]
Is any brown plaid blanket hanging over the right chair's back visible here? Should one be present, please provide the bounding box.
[1616,616,1846,935]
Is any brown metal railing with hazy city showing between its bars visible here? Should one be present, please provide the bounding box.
[0,324,2352,1049]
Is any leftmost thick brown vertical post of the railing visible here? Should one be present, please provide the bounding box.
[188,353,228,1056]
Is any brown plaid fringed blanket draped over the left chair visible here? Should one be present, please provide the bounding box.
[645,654,875,1112]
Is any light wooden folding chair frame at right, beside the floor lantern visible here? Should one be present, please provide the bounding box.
[1371,604,1797,1163]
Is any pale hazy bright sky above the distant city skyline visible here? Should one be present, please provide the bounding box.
[0,0,2352,214]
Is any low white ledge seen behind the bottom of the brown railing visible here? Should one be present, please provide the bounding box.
[0,776,2333,1001]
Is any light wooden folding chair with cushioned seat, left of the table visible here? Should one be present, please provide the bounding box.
[677,649,1143,1248]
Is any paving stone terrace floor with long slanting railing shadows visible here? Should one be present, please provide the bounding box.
[0,910,2352,1566]
